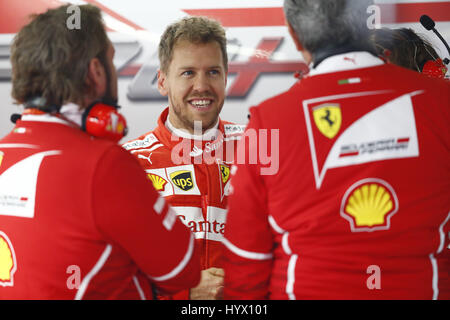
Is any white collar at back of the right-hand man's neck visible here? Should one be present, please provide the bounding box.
[307,51,384,76]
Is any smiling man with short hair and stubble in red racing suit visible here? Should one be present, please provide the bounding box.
[124,17,243,299]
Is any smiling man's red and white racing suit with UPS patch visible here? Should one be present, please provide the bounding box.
[123,108,244,299]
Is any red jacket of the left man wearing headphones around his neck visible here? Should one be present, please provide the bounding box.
[0,110,200,299]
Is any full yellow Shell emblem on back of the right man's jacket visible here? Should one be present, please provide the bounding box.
[341,178,398,232]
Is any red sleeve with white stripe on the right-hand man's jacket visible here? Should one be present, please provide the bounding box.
[224,109,273,300]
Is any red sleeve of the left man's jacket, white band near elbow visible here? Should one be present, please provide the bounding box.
[92,146,200,293]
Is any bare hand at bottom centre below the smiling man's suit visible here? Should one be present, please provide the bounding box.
[189,268,225,300]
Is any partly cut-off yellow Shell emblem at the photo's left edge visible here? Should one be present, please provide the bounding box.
[0,231,17,287]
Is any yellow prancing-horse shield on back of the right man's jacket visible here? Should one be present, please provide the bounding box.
[313,103,342,139]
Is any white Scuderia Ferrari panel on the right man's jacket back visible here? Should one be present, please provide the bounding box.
[304,91,422,189]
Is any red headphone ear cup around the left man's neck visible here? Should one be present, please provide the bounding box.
[82,102,127,142]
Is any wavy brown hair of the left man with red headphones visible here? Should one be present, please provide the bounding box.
[11,5,108,105]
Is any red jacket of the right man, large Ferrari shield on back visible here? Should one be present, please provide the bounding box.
[224,52,450,299]
